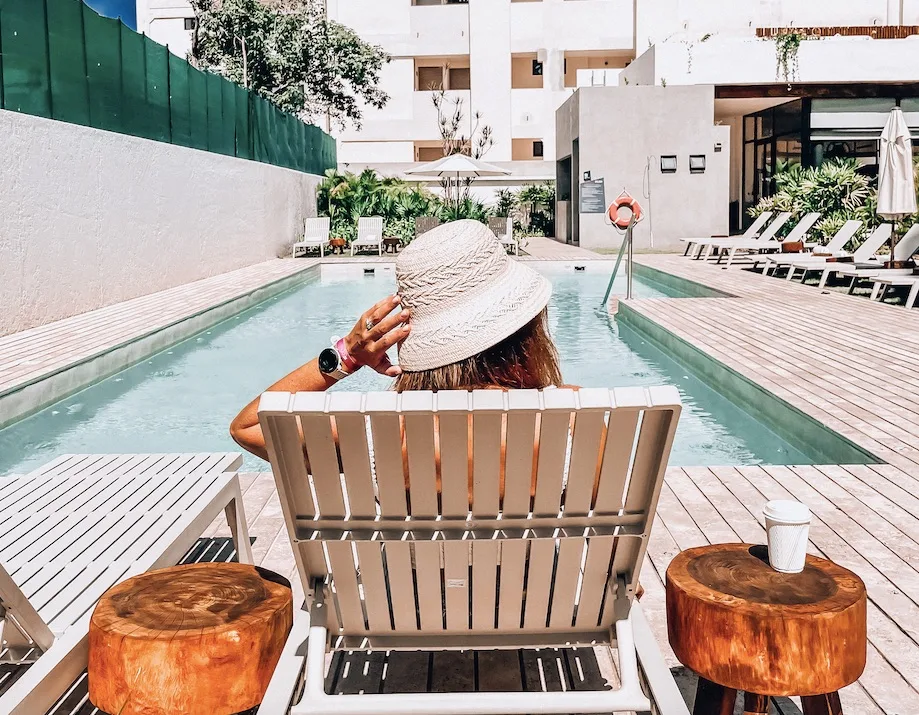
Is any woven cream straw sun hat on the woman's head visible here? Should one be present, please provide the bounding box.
[396,220,552,371]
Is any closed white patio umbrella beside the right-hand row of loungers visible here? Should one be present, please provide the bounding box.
[877,107,916,262]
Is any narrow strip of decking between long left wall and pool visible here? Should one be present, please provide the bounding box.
[0,259,318,394]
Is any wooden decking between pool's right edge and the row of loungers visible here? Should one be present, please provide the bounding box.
[629,255,919,470]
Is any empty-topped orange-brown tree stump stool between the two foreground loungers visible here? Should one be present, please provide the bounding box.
[89,563,293,715]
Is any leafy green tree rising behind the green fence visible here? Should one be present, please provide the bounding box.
[190,0,390,127]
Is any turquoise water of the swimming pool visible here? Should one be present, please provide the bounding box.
[0,264,813,474]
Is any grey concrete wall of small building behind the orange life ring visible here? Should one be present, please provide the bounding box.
[556,86,730,250]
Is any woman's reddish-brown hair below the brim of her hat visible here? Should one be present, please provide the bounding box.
[394,308,562,392]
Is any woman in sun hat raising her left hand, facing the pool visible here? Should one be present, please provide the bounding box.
[230,221,561,460]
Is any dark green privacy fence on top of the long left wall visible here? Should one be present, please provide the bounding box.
[0,0,336,174]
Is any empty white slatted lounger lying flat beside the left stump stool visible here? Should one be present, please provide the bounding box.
[0,454,252,715]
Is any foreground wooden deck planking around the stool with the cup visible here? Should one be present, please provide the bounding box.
[223,465,919,715]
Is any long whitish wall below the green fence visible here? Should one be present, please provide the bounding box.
[0,111,319,335]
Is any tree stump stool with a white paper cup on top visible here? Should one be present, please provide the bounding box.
[667,544,868,715]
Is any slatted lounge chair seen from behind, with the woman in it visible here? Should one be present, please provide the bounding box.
[259,387,688,715]
